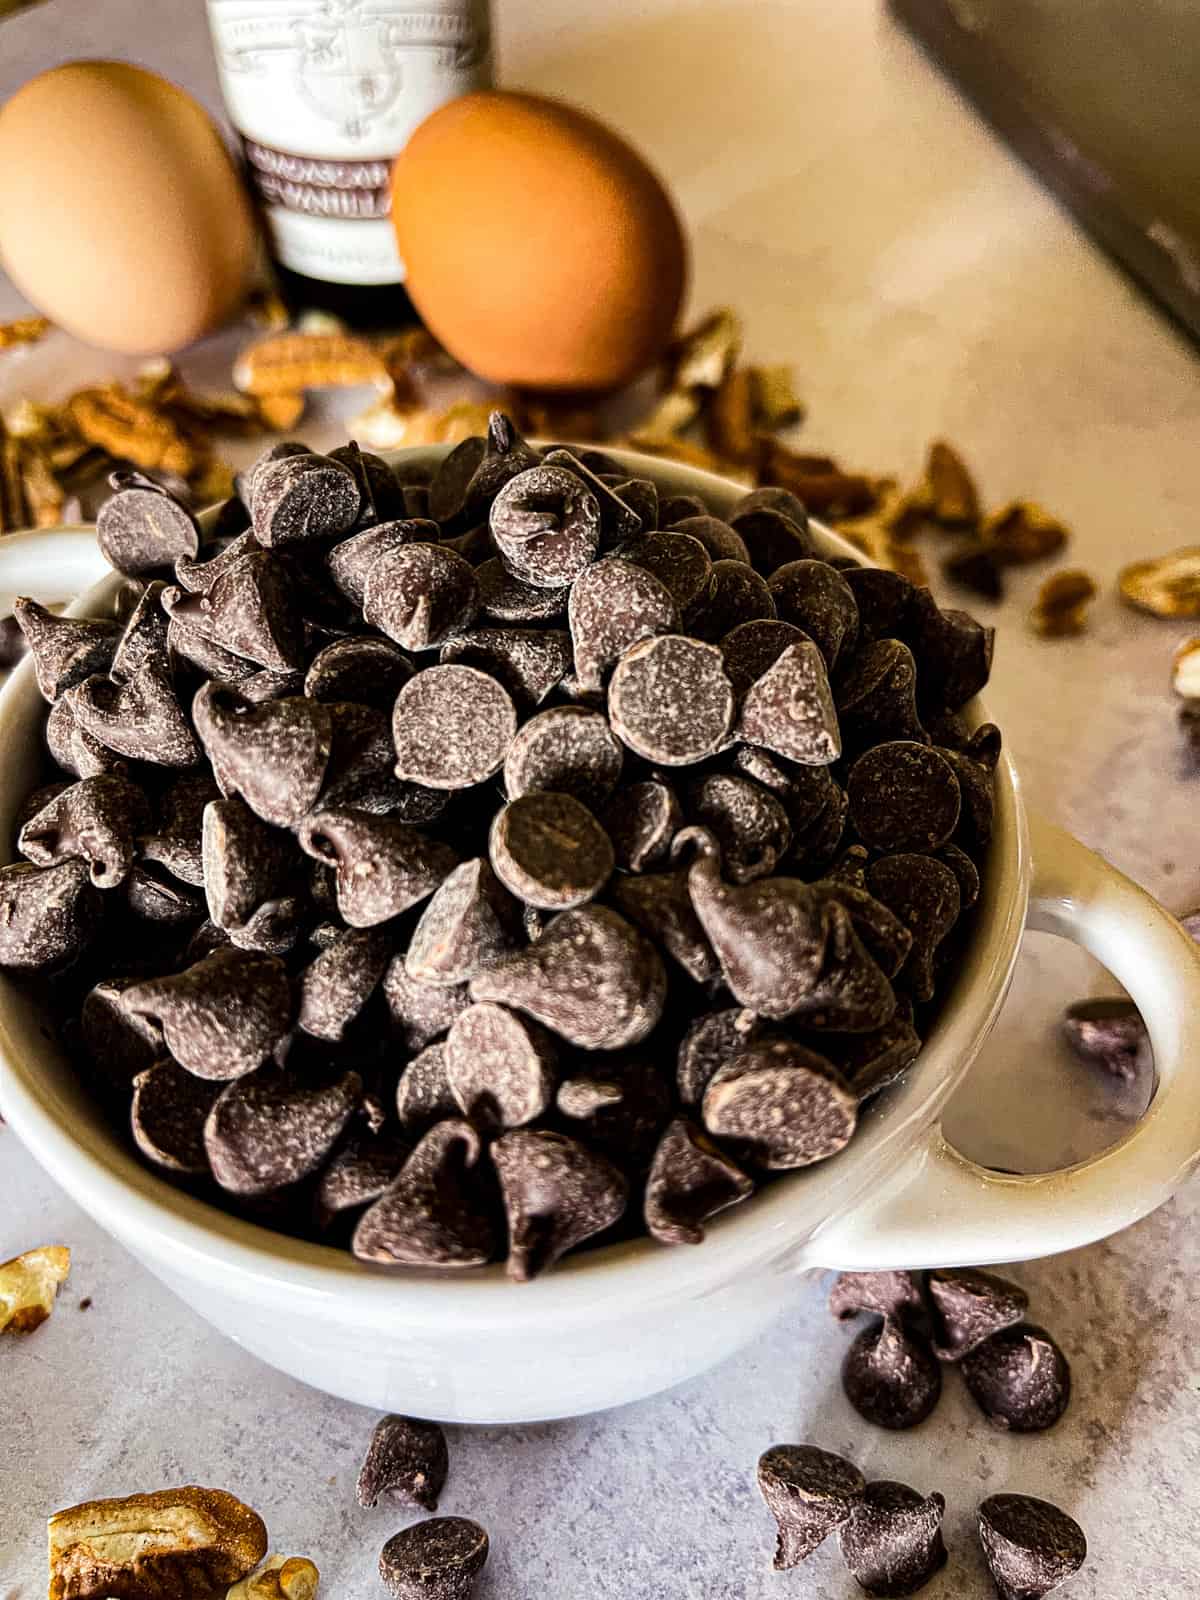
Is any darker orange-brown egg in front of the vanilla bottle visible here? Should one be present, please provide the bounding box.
[392,91,686,389]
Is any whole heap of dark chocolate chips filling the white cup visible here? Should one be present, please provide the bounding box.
[0,413,1000,1278]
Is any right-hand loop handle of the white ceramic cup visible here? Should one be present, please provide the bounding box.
[803,816,1200,1270]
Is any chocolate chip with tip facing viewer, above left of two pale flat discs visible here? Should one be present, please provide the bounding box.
[363,544,478,650]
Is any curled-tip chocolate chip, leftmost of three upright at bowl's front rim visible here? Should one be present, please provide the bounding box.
[350,1118,496,1267]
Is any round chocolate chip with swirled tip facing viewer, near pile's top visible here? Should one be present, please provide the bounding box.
[488,466,600,589]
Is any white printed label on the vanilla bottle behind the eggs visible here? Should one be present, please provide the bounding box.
[208,0,491,283]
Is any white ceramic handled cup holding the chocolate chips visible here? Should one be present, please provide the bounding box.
[0,450,1200,1422]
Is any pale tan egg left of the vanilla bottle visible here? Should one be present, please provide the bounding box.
[0,61,254,352]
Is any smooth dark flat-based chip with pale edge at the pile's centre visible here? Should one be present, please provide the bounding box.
[488,789,614,910]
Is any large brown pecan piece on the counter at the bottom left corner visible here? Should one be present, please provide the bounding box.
[46,1486,268,1600]
